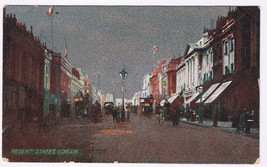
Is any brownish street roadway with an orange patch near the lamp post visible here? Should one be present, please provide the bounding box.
[3,116,259,164]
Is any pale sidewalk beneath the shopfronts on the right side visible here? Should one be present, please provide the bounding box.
[180,118,259,139]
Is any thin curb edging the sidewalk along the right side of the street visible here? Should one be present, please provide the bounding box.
[180,120,259,139]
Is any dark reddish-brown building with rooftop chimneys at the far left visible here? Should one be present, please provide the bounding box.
[3,13,45,127]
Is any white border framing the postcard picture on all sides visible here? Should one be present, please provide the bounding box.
[0,0,267,167]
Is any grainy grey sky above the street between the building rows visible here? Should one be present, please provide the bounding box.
[6,6,229,98]
